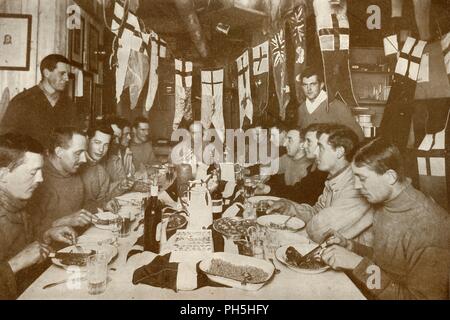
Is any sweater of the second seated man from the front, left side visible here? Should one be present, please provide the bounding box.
[27,159,85,232]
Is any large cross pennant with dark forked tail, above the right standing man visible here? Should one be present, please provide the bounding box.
[314,0,357,106]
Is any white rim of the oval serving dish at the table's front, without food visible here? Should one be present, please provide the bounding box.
[199,252,275,291]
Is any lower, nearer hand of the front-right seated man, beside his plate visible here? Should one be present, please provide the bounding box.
[321,244,363,270]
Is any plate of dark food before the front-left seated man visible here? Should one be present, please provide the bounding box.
[50,243,118,269]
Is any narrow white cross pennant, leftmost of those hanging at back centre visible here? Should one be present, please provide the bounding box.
[173,59,192,130]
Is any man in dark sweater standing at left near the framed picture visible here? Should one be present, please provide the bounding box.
[0,54,78,147]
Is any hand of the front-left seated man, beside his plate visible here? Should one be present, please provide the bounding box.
[8,241,52,273]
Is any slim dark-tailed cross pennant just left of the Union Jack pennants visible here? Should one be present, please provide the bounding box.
[252,41,269,122]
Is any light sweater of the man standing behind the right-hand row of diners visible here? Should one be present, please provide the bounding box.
[298,100,364,141]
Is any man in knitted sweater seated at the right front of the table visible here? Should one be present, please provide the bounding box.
[321,139,450,300]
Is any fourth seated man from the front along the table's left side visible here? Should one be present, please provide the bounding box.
[105,118,136,182]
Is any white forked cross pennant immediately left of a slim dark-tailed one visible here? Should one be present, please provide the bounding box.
[236,50,253,128]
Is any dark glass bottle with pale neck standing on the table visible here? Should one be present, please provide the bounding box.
[144,182,162,253]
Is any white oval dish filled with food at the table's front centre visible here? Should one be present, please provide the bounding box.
[199,252,275,291]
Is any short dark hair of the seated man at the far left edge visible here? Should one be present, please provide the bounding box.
[0,133,44,171]
